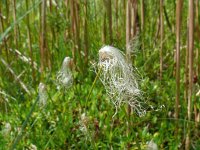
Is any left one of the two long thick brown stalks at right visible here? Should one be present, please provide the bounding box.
[175,0,182,134]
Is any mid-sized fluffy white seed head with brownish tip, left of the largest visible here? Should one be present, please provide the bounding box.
[57,57,73,89]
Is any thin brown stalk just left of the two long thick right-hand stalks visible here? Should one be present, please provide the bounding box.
[160,0,164,80]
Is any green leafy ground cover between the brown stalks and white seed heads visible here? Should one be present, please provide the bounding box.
[0,1,200,150]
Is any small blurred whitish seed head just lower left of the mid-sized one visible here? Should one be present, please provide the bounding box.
[38,83,48,107]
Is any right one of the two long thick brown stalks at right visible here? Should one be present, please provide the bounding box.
[185,0,194,150]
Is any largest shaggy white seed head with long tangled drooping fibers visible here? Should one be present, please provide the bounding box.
[98,46,146,116]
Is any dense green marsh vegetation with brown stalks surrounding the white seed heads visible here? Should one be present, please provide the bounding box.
[0,0,200,150]
